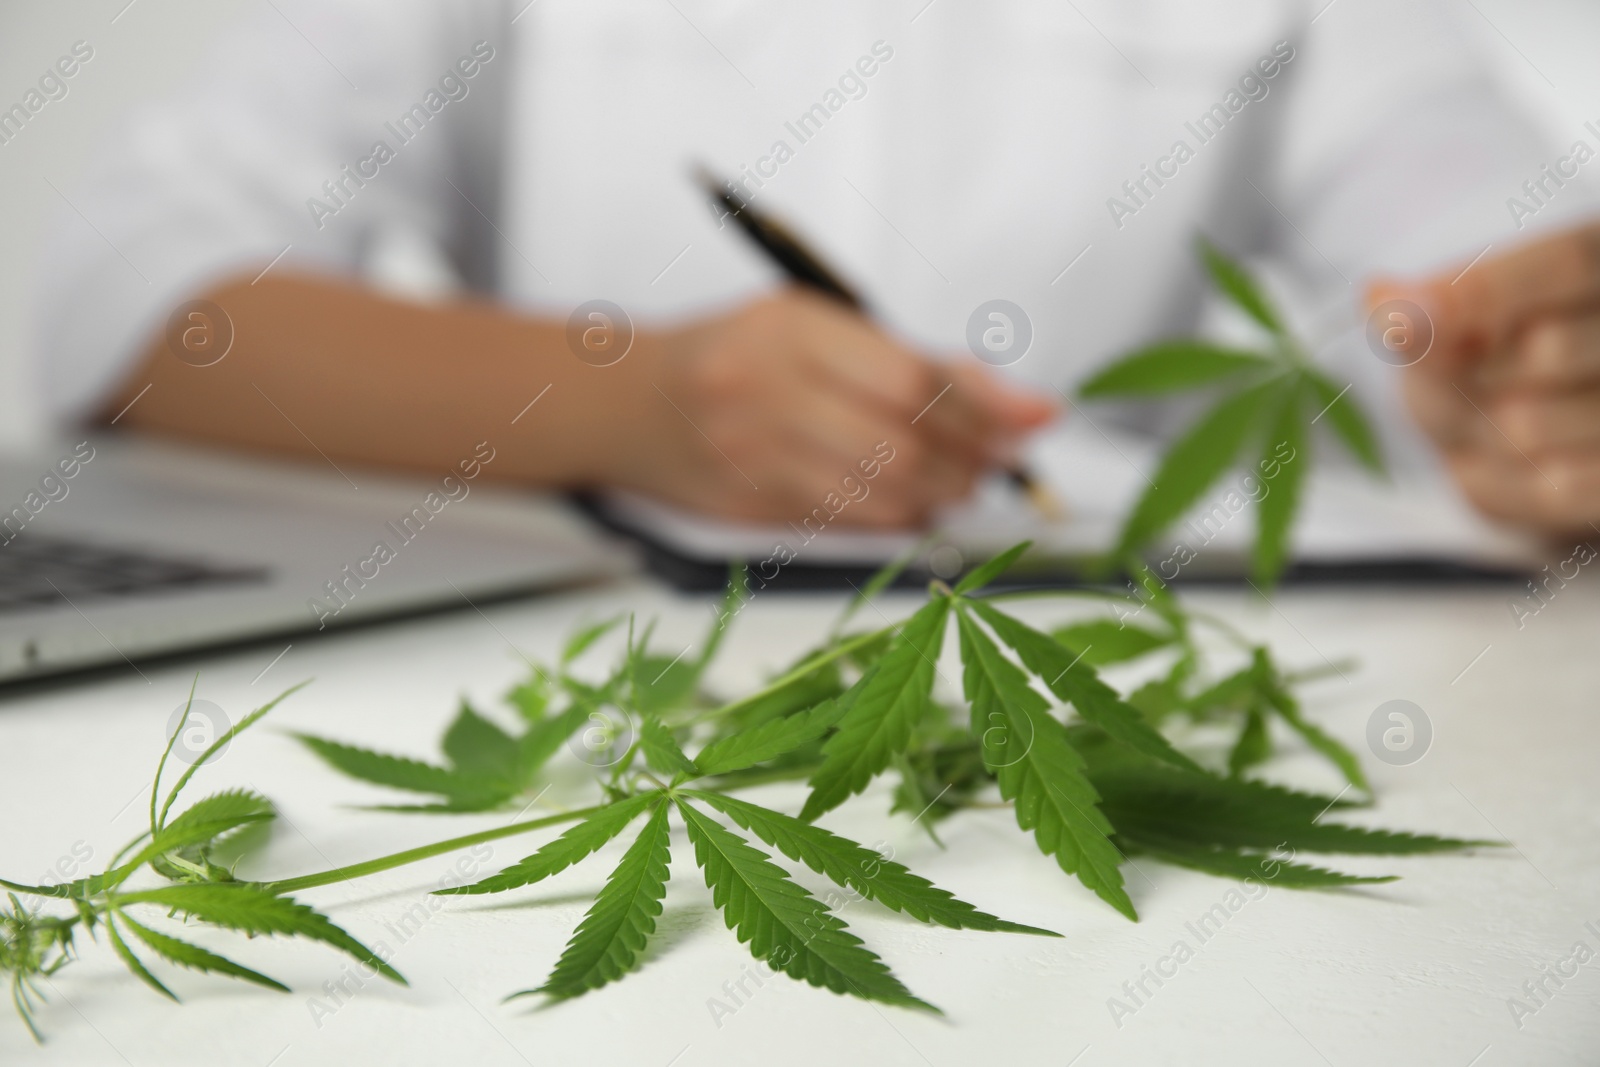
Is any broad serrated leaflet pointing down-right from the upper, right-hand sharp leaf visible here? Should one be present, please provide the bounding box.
[955,611,1138,920]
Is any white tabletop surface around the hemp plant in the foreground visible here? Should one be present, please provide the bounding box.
[0,574,1600,1067]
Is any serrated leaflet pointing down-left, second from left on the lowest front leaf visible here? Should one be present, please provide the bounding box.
[528,797,670,997]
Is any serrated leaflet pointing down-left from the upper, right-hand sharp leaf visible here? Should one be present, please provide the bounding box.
[800,597,950,822]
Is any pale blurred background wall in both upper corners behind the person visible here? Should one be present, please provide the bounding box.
[0,0,1600,450]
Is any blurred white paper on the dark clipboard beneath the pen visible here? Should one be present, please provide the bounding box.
[608,418,1539,573]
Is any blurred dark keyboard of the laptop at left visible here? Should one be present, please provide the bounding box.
[0,533,267,613]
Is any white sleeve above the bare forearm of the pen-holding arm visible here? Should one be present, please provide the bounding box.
[34,0,510,422]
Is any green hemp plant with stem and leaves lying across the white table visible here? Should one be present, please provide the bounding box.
[0,544,1480,1035]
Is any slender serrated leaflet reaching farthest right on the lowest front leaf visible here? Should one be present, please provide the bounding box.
[690,790,1061,937]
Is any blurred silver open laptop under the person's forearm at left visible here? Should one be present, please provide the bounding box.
[0,437,635,683]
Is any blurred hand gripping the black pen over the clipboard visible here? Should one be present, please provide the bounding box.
[634,290,1058,528]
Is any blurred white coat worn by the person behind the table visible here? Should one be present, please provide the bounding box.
[35,0,1600,476]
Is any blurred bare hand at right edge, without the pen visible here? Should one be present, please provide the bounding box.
[1368,226,1600,537]
